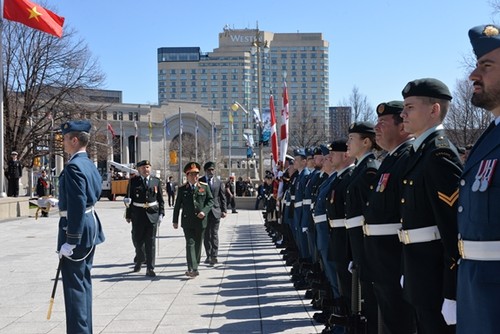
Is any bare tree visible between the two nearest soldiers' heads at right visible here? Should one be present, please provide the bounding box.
[444,78,492,146]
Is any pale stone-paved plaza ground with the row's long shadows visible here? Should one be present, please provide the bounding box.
[0,199,323,334]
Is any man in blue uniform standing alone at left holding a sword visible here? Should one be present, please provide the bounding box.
[57,120,104,334]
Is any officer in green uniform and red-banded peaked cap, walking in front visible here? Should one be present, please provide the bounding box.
[172,162,214,278]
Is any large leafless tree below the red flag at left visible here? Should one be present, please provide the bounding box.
[2,20,104,167]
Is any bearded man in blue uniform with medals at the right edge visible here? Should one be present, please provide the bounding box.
[457,25,500,334]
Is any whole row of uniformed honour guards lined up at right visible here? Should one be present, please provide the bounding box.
[264,25,500,334]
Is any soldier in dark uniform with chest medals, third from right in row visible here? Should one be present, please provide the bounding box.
[363,101,415,334]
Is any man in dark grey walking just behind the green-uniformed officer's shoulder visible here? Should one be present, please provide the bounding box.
[200,161,227,266]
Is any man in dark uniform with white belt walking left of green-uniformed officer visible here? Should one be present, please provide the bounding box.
[125,160,165,277]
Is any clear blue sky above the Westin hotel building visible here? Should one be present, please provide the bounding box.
[51,0,493,107]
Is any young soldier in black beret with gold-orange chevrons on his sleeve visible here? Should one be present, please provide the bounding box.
[399,78,462,334]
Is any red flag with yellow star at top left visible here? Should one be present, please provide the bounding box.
[3,0,64,37]
